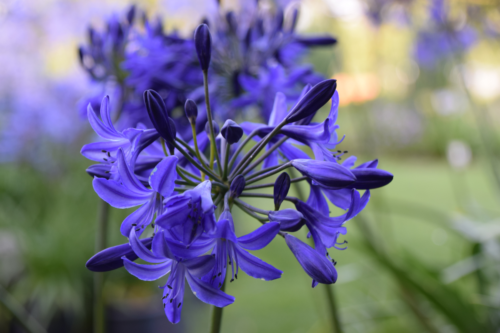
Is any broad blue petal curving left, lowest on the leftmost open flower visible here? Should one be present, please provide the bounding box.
[92,178,151,208]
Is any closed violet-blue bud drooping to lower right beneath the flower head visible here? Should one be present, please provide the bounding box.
[285,234,337,284]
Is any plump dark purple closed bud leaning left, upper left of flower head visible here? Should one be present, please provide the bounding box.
[144,89,176,154]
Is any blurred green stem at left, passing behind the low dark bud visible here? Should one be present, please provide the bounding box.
[94,200,109,333]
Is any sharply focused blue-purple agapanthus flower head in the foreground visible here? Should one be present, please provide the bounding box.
[82,12,392,323]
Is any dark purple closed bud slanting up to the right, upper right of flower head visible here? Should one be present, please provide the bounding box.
[286,80,337,124]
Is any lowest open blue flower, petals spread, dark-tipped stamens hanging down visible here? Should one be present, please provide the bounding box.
[123,229,234,324]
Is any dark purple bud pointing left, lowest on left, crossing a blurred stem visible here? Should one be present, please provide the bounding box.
[85,238,153,272]
